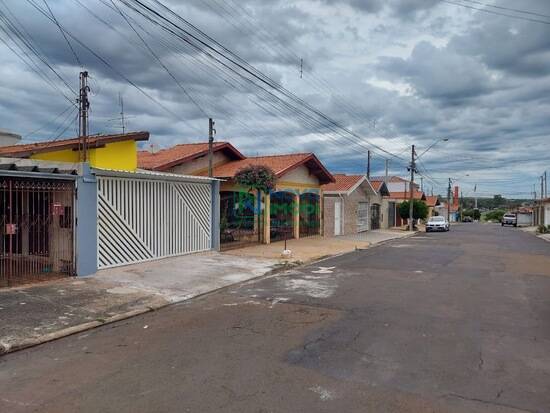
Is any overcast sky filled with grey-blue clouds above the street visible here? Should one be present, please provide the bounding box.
[0,0,550,198]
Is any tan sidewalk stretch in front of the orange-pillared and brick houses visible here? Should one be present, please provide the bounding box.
[226,229,415,264]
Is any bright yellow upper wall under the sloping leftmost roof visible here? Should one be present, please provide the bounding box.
[31,140,137,171]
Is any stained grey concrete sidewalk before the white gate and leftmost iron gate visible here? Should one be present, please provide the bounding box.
[0,253,280,354]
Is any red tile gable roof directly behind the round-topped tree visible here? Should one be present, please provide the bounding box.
[205,153,334,184]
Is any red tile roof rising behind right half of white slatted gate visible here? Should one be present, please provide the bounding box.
[138,142,245,171]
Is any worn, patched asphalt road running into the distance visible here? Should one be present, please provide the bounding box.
[0,224,550,413]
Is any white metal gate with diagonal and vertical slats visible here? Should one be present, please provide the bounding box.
[97,176,212,269]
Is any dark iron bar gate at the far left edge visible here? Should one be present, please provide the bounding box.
[0,177,74,287]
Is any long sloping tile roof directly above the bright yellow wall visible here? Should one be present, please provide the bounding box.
[0,132,149,158]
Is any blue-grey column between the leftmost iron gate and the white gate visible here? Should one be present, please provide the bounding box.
[75,163,97,276]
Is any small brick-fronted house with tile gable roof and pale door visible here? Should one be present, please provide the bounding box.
[323,174,389,236]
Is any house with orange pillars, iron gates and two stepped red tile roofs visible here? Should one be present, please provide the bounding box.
[138,142,334,249]
